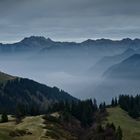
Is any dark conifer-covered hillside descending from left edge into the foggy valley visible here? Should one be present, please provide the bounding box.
[0,73,77,115]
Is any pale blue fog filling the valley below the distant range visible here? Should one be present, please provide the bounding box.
[0,41,139,103]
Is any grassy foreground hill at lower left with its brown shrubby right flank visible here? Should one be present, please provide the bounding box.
[0,109,120,140]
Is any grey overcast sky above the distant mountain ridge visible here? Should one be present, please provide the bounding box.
[0,0,140,42]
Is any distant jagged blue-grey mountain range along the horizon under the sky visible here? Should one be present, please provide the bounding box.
[0,36,140,54]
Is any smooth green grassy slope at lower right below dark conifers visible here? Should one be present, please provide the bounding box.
[108,107,140,140]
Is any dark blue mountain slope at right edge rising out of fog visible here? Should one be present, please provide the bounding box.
[104,54,140,80]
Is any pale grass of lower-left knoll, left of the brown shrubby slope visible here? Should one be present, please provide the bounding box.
[0,116,45,140]
